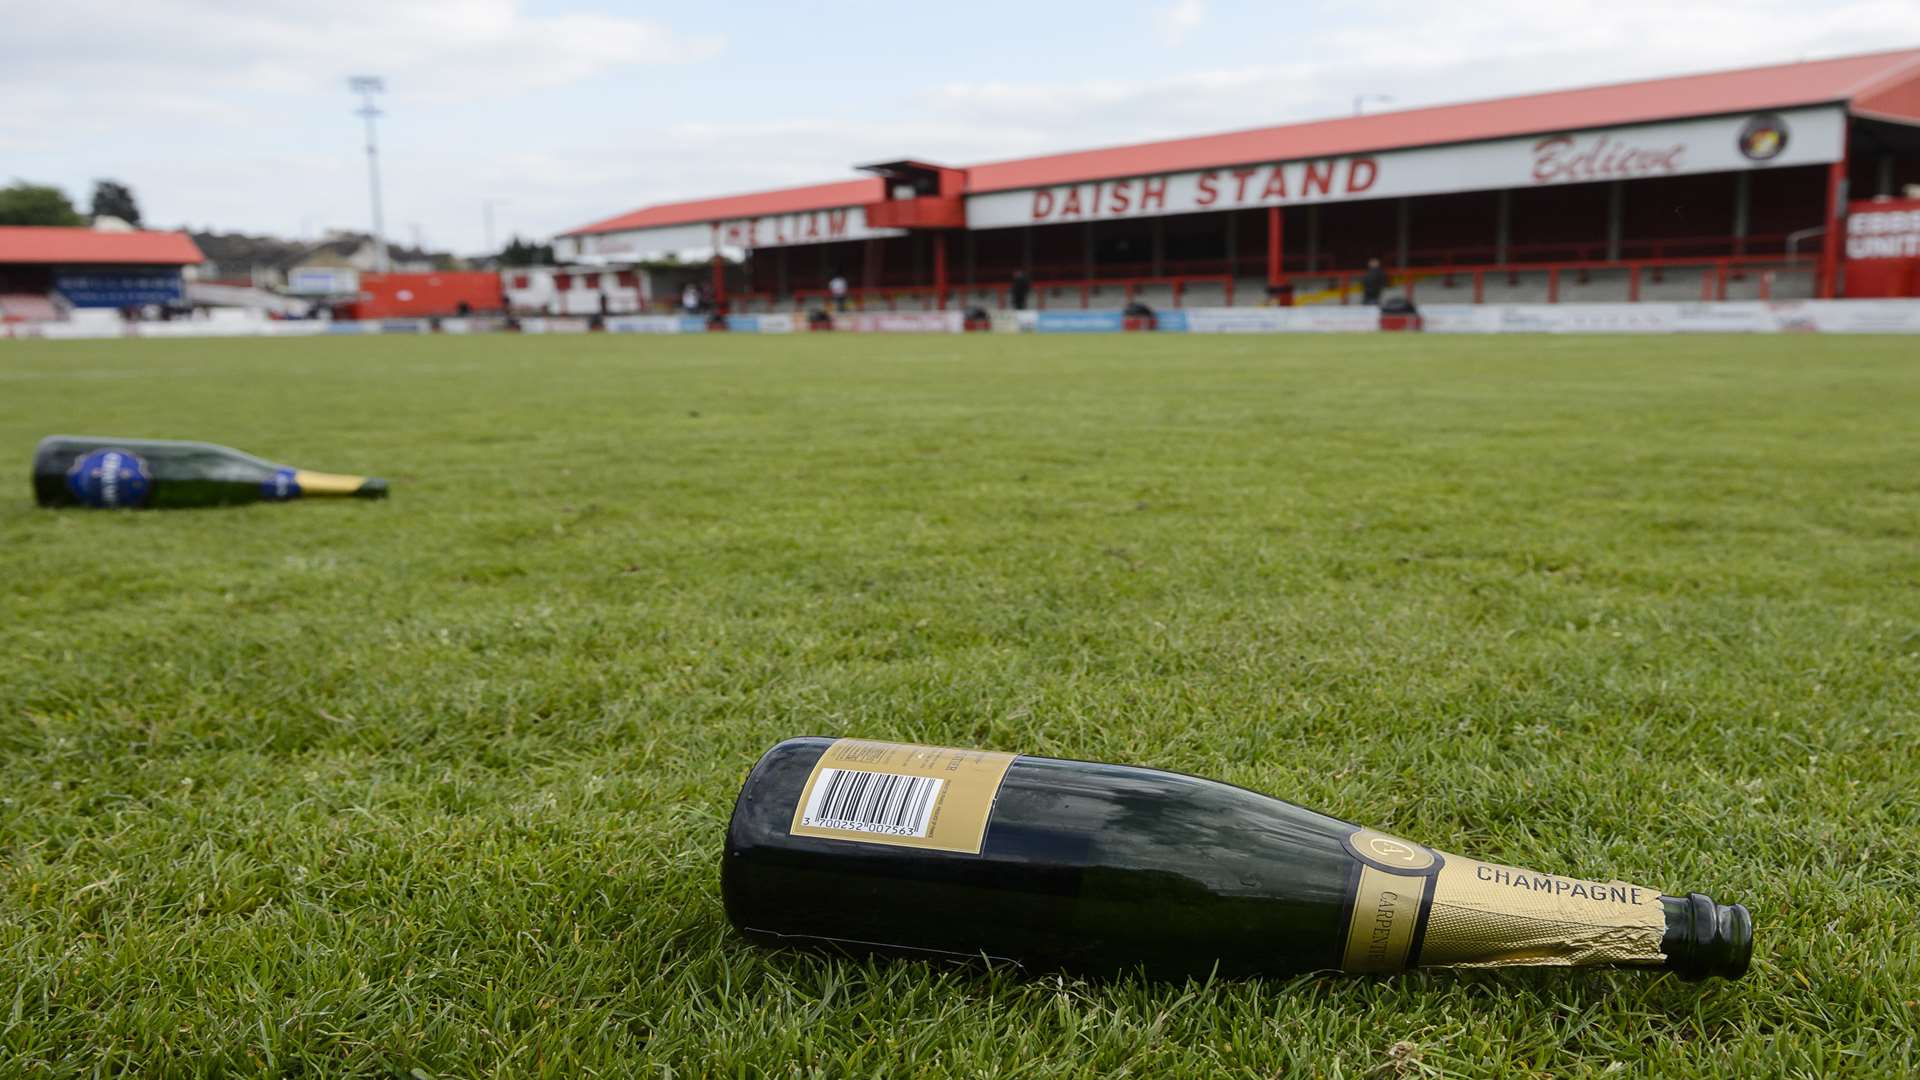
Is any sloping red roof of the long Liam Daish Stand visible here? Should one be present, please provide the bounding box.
[563,48,1920,236]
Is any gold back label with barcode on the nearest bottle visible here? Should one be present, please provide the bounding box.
[789,738,1018,855]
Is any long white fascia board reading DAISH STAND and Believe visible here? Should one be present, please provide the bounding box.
[966,106,1845,229]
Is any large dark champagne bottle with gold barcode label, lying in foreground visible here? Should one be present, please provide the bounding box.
[720,738,1753,978]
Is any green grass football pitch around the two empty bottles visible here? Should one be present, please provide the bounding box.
[0,334,1920,1078]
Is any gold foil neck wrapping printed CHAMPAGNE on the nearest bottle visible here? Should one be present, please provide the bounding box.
[1340,828,1667,972]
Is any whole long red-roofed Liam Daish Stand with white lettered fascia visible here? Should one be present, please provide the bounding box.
[549,50,1920,313]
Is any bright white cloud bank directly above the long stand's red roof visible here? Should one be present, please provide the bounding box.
[927,0,1920,156]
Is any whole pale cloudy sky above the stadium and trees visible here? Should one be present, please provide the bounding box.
[11,0,1920,254]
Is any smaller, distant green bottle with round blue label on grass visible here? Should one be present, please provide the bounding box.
[33,434,386,509]
